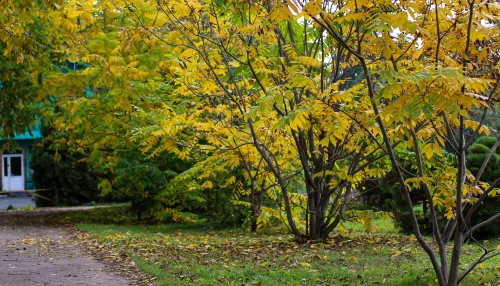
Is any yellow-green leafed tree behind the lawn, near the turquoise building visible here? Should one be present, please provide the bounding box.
[33,1,209,221]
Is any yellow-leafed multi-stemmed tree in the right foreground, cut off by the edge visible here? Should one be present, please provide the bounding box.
[293,1,500,285]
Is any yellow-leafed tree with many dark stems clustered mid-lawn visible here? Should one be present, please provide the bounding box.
[121,1,398,240]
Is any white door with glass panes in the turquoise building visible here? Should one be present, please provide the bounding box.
[2,154,24,191]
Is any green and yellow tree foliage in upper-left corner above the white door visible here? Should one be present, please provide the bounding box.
[0,1,52,138]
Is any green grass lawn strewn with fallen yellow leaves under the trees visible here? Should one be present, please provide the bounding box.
[68,207,500,285]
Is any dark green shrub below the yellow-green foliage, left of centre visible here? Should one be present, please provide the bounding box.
[112,149,203,223]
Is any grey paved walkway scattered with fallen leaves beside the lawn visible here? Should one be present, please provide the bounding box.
[0,208,139,286]
